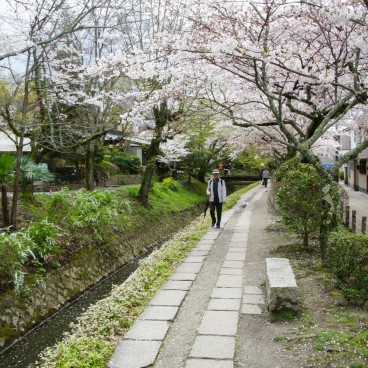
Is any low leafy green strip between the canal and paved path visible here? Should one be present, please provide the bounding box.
[39,183,258,368]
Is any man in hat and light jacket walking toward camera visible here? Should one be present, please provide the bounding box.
[207,169,226,228]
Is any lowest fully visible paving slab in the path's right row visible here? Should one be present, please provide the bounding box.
[189,336,235,359]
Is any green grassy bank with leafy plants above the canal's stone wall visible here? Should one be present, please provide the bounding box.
[0,179,206,293]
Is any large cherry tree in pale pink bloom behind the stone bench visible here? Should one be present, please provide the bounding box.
[157,0,368,258]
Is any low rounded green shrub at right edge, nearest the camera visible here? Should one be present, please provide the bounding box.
[327,227,368,298]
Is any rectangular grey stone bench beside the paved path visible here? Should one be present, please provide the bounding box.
[266,258,300,312]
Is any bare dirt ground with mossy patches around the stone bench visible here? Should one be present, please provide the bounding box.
[235,193,368,368]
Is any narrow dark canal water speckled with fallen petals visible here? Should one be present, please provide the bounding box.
[0,242,163,368]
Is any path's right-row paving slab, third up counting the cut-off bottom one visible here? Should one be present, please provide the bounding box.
[198,310,239,336]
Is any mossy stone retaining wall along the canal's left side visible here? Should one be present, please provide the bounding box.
[0,206,203,347]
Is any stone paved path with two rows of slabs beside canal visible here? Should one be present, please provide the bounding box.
[109,186,264,368]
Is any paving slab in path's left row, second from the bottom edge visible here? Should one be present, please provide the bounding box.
[125,320,169,341]
